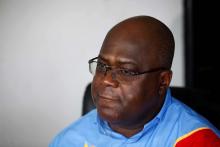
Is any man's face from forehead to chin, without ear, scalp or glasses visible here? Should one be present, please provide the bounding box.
[92,32,160,125]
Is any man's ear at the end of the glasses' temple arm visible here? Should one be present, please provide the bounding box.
[159,70,173,95]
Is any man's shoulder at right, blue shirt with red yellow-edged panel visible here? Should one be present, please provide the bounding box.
[170,98,220,147]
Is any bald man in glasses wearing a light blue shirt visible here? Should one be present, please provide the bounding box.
[50,16,220,147]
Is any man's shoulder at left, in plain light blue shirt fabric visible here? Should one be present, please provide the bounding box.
[50,110,97,147]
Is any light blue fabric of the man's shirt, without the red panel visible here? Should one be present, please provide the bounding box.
[49,89,220,147]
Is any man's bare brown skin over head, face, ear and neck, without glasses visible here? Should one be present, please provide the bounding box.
[92,16,174,137]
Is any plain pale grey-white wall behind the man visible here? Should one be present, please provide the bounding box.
[0,0,184,147]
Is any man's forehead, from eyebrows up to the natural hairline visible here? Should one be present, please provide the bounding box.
[100,36,156,68]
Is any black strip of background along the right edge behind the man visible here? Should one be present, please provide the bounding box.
[184,0,220,128]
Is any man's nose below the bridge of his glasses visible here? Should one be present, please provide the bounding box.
[104,70,119,88]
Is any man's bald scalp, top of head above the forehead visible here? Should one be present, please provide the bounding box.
[101,16,174,69]
